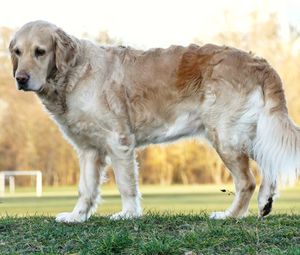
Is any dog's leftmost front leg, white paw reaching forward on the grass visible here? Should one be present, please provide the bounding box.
[56,150,104,222]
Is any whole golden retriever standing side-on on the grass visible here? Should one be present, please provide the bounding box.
[9,21,300,222]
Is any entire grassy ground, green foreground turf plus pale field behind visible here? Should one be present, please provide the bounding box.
[0,185,300,255]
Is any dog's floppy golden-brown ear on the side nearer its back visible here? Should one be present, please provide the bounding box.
[54,28,78,73]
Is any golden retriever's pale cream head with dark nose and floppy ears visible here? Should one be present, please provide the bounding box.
[9,21,78,91]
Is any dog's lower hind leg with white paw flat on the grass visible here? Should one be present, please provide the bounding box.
[210,148,255,219]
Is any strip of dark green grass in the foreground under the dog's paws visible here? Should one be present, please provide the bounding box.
[0,213,300,255]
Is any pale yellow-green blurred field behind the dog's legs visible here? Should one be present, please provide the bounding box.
[0,185,300,216]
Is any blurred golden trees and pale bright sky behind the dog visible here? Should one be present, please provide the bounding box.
[0,0,300,215]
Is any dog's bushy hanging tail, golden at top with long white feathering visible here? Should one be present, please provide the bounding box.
[253,67,300,185]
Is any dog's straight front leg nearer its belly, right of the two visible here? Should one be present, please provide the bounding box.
[110,134,142,220]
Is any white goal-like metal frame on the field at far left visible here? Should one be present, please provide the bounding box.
[0,170,42,197]
